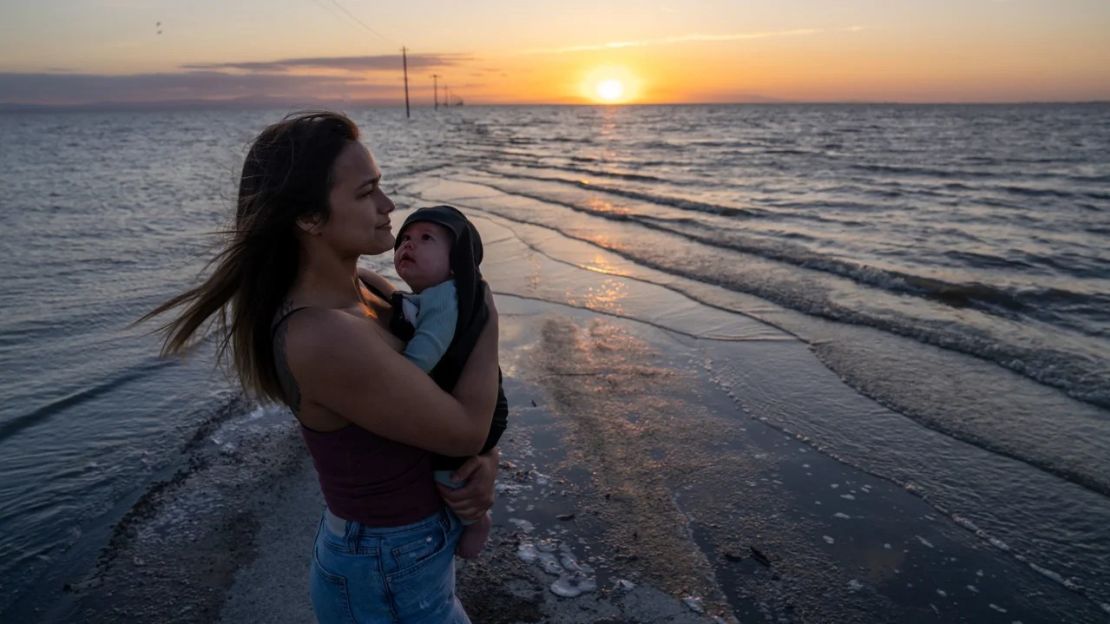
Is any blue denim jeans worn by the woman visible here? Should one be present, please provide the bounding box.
[309,509,471,624]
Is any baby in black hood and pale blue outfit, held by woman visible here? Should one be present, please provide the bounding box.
[392,205,508,558]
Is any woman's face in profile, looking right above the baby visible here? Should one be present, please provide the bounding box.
[320,141,394,255]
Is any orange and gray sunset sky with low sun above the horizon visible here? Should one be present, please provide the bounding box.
[0,0,1110,105]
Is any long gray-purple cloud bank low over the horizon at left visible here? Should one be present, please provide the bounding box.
[0,71,401,105]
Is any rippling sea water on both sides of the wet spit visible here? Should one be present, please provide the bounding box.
[0,105,1110,612]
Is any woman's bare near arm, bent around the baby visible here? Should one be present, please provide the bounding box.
[285,305,497,456]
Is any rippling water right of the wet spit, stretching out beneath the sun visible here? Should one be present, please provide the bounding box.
[452,105,1110,407]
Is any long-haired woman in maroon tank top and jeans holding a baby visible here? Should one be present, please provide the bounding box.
[151,112,497,624]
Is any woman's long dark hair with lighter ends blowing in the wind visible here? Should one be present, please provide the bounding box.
[141,112,359,401]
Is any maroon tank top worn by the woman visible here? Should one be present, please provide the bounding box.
[273,308,444,526]
